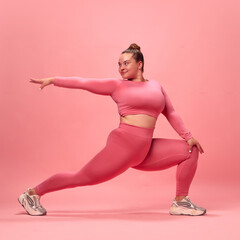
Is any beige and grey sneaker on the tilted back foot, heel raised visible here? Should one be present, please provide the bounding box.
[18,188,47,216]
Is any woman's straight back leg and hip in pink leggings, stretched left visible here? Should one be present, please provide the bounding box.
[34,124,153,196]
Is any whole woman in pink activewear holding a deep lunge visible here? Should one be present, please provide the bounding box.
[18,43,206,216]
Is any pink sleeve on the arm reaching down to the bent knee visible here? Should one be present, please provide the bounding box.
[161,86,193,141]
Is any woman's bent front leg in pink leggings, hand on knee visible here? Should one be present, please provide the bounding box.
[132,138,199,196]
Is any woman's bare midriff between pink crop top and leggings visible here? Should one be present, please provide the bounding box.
[120,114,157,128]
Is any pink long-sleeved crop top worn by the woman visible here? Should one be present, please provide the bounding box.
[53,76,192,141]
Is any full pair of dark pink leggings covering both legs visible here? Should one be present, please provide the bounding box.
[35,122,199,196]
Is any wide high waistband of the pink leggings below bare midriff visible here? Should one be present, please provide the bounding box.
[119,122,155,137]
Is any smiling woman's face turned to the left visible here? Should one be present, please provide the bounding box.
[118,53,141,79]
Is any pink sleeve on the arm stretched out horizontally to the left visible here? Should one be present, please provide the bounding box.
[52,76,121,95]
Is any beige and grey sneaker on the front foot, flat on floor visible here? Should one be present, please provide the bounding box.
[169,196,207,216]
